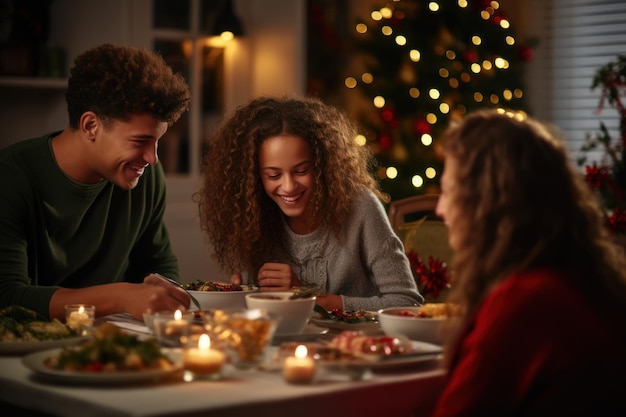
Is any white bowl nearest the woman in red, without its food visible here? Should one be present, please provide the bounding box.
[378,307,446,345]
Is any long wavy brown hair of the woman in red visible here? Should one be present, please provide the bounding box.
[443,110,626,354]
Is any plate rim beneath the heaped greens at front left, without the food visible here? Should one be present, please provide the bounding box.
[22,349,182,385]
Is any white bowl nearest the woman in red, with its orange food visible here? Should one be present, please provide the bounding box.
[378,303,459,345]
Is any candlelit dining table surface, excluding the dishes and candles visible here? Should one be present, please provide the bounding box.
[0,315,444,417]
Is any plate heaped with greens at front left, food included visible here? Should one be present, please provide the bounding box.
[22,323,182,385]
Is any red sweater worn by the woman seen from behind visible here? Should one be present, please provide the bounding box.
[433,270,626,417]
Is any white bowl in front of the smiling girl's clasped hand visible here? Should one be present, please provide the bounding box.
[246,291,316,335]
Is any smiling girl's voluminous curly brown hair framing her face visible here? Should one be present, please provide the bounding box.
[196,97,388,277]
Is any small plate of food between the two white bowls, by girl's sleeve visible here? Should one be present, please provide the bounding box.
[310,304,380,331]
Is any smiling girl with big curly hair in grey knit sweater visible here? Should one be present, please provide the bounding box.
[199,97,423,310]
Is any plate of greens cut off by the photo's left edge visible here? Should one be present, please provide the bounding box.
[0,306,85,355]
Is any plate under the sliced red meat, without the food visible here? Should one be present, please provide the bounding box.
[320,341,442,371]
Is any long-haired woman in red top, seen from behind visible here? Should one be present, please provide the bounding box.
[433,111,626,417]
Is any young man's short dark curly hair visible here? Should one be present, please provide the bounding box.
[65,43,191,129]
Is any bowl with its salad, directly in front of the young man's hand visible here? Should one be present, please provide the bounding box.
[183,281,259,310]
